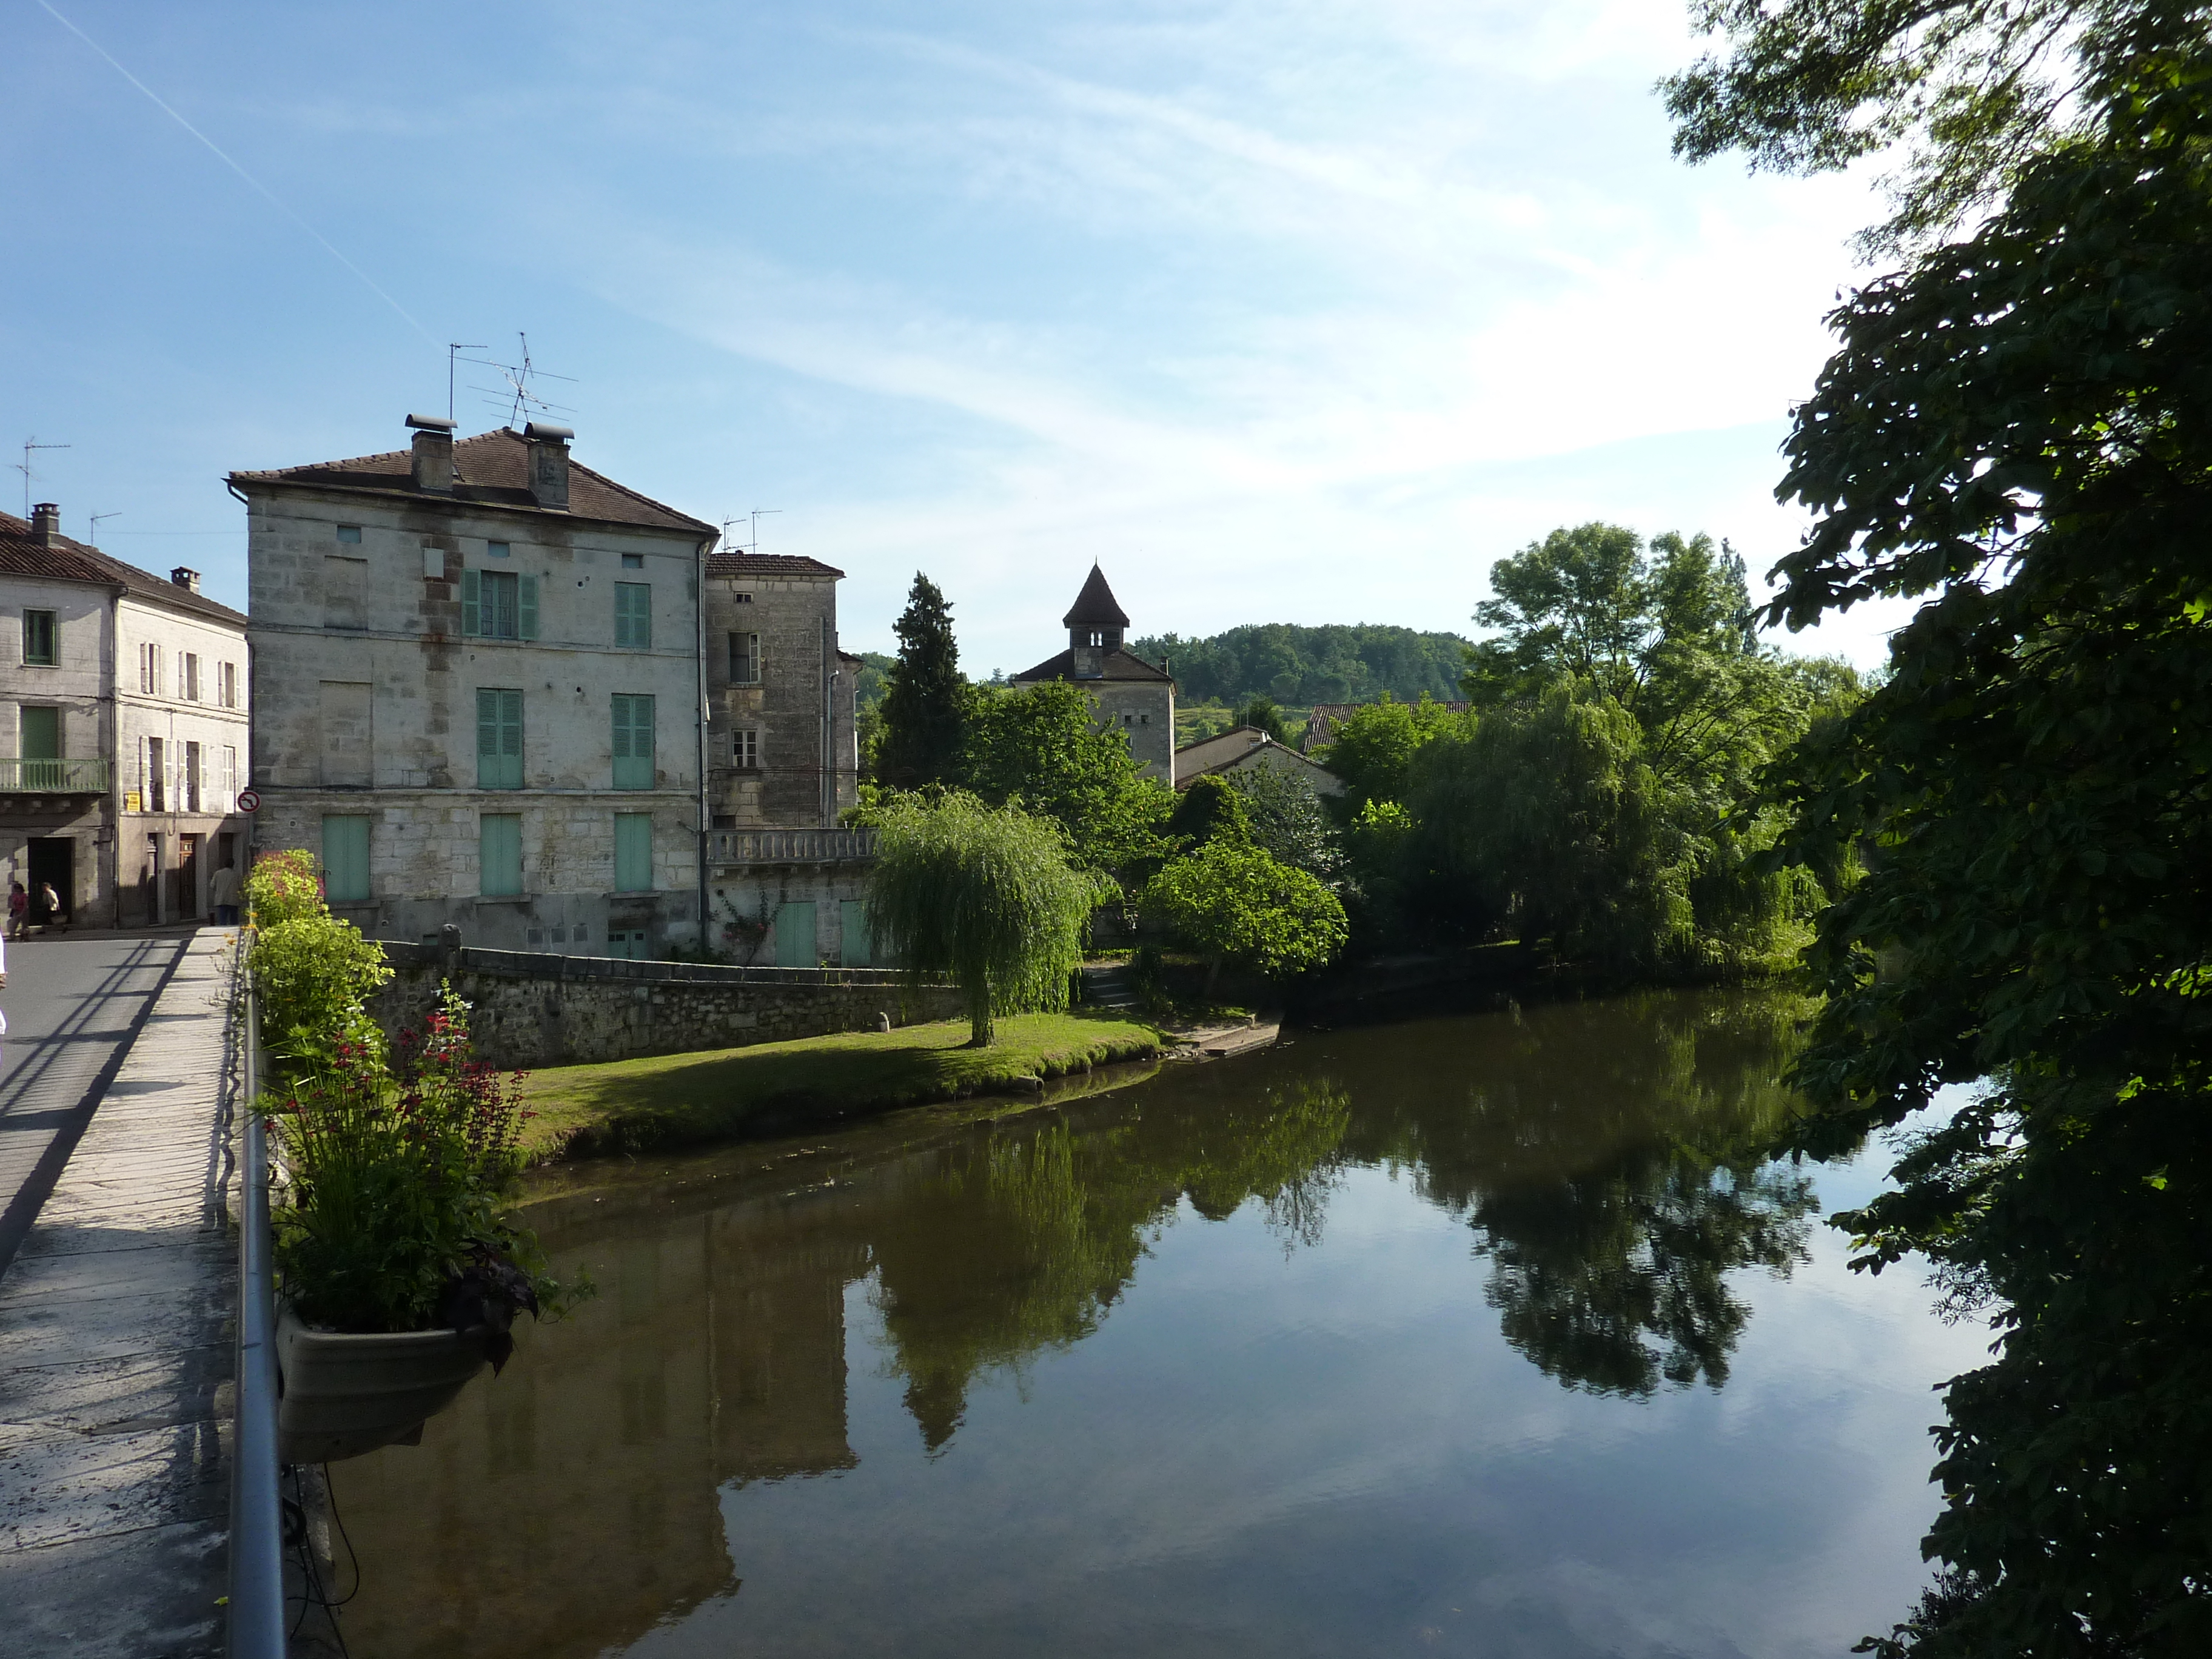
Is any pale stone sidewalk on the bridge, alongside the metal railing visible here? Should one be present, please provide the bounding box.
[0,929,236,1659]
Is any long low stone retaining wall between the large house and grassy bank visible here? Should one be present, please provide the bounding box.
[369,945,965,1068]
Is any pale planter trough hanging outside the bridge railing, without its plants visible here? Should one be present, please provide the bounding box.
[276,1307,484,1462]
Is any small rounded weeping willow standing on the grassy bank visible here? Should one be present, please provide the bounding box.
[870,792,1102,1048]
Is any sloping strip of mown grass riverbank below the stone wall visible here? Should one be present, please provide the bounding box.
[522,1013,1161,1164]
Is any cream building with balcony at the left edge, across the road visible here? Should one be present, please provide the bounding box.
[0,502,248,927]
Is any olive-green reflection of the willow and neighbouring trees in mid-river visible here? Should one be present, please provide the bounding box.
[874,1082,1352,1451]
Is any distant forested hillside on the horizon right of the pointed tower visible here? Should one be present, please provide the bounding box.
[1130,622,1467,706]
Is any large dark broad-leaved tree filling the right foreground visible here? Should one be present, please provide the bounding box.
[1774,39,2212,1659]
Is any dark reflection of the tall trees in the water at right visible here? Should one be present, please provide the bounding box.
[1361,993,1816,1393]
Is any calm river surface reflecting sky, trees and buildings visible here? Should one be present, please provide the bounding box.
[334,991,1986,1659]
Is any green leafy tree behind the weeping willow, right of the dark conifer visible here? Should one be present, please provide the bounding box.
[965,679,1175,871]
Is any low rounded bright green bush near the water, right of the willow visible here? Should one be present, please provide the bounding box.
[1144,836,1347,980]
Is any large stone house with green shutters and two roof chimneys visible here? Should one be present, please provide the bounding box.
[230,416,717,956]
